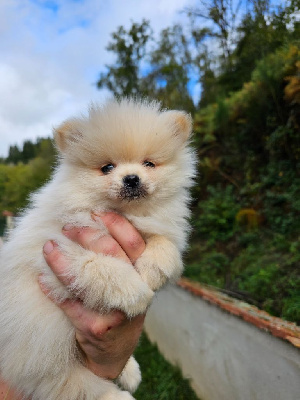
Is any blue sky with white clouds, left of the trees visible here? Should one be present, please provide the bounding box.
[0,0,195,157]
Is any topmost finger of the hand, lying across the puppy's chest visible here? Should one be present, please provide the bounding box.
[92,212,146,264]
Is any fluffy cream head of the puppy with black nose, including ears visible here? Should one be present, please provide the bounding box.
[55,100,191,209]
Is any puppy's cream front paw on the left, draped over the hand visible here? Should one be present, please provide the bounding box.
[71,254,154,317]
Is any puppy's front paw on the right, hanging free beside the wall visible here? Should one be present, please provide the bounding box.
[135,235,183,290]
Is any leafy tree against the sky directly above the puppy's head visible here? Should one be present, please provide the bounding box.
[97,20,194,112]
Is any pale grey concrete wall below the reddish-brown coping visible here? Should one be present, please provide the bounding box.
[145,286,300,400]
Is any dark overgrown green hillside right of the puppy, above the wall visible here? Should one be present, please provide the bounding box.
[186,42,300,322]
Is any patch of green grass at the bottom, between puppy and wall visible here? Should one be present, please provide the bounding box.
[134,333,199,400]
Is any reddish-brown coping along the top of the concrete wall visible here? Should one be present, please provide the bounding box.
[177,278,300,348]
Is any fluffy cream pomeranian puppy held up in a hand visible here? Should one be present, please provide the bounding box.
[0,99,195,400]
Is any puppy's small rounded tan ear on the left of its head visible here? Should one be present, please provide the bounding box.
[53,119,83,153]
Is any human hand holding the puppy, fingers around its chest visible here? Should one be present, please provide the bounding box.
[40,212,145,379]
